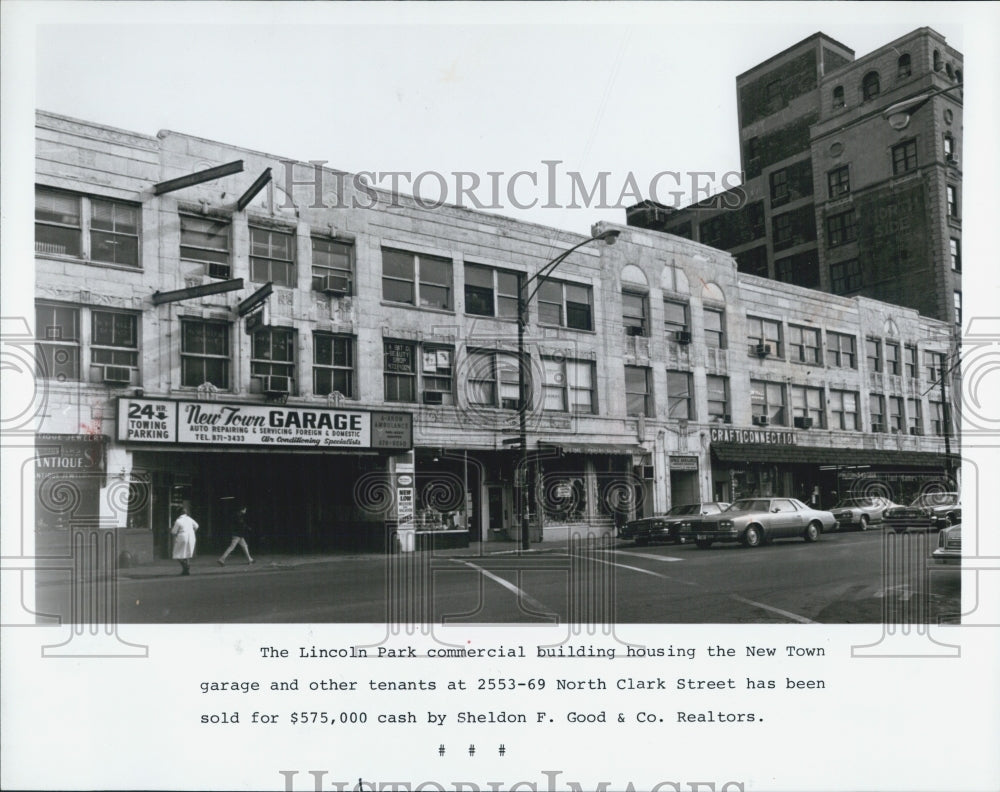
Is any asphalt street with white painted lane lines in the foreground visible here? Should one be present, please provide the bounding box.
[37,530,960,624]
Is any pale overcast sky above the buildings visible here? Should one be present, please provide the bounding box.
[13,3,984,231]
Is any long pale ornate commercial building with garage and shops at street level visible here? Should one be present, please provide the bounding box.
[34,113,950,561]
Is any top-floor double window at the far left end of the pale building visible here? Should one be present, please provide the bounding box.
[35,187,139,267]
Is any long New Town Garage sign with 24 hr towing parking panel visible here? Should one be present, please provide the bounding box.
[118,398,413,450]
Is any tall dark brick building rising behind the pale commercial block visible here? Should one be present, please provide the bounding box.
[627,27,963,325]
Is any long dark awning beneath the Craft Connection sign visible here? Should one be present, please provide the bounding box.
[711,443,958,468]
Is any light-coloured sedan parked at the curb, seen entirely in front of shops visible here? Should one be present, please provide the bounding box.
[681,498,837,549]
